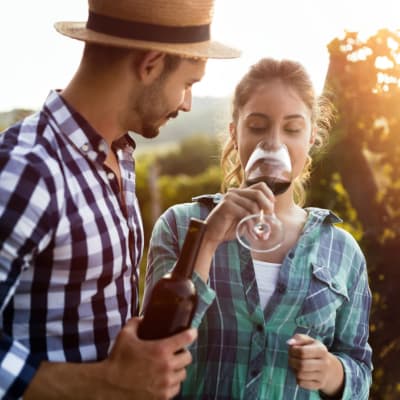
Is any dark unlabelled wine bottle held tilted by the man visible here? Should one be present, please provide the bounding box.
[138,218,206,340]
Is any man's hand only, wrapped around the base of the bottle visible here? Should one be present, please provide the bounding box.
[104,318,197,400]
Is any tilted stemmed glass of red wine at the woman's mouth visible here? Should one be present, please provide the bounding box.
[236,140,292,253]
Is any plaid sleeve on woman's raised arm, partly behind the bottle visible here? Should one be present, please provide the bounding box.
[142,209,215,327]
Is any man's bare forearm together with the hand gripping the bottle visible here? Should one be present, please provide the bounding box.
[24,317,197,400]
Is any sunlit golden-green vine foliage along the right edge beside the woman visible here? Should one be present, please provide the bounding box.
[309,30,400,400]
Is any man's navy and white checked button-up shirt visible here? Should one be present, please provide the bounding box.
[0,92,143,399]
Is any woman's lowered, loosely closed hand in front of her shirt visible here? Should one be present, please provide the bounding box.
[288,334,344,396]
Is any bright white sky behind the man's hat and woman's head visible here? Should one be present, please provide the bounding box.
[0,0,400,112]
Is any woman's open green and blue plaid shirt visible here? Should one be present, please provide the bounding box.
[144,195,372,400]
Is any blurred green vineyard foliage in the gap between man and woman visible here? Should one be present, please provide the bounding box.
[136,135,221,243]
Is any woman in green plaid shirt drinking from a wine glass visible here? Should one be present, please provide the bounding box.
[144,59,372,400]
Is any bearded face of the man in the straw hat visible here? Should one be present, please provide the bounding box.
[136,59,207,138]
